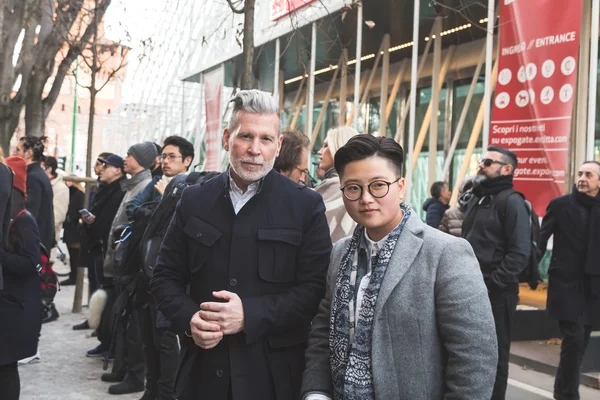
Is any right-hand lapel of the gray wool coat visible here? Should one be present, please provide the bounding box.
[375,213,423,315]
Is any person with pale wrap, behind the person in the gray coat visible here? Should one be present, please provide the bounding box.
[315,126,359,243]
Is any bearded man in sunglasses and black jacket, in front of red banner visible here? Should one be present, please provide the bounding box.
[462,146,532,400]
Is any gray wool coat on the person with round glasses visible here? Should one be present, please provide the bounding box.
[302,214,498,400]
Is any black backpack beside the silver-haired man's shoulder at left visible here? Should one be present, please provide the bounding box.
[140,171,219,280]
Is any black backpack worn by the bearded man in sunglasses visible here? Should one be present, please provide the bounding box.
[494,189,542,290]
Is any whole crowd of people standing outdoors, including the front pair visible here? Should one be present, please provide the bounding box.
[0,90,600,400]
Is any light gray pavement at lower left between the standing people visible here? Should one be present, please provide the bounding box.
[19,278,143,400]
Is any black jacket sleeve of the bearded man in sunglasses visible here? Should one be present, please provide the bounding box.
[491,195,531,288]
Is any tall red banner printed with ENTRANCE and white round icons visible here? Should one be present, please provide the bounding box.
[490,0,583,216]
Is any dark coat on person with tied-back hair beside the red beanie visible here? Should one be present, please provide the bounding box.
[25,162,55,252]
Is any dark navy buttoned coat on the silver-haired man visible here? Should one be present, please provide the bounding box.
[151,171,331,400]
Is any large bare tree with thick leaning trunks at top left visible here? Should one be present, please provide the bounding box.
[0,0,111,150]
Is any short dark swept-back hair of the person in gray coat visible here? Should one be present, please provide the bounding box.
[334,134,404,177]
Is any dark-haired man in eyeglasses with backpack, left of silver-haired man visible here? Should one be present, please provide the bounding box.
[127,136,194,400]
